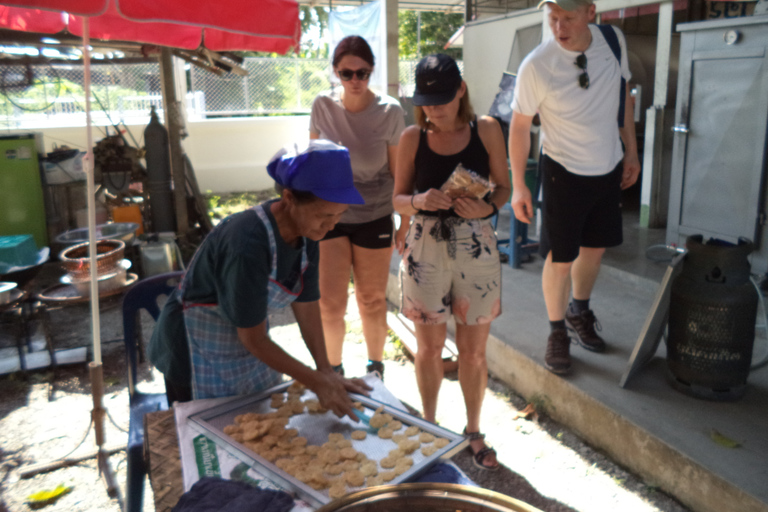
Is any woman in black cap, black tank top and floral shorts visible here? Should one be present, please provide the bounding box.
[394,54,510,469]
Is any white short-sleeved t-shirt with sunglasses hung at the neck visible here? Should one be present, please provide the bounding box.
[512,25,632,176]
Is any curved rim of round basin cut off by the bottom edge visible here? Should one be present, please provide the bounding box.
[317,483,541,512]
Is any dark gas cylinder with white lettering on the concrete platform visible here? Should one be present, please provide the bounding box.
[667,235,758,400]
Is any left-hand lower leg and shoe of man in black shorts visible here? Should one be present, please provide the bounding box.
[541,251,573,374]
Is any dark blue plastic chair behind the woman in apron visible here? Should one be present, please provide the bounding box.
[123,272,183,512]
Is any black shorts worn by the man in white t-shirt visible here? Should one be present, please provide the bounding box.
[539,155,623,263]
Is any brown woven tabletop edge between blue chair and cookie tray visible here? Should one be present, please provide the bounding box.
[144,410,184,512]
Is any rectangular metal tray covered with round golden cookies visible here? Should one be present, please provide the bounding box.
[188,381,468,507]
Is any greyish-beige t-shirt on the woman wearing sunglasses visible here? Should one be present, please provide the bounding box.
[309,93,405,224]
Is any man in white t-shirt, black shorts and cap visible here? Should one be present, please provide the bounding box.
[509,0,640,374]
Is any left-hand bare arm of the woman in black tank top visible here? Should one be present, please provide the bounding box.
[392,129,453,216]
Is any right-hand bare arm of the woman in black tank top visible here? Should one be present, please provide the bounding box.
[454,116,512,219]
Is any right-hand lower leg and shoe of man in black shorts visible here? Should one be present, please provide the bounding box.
[565,247,605,352]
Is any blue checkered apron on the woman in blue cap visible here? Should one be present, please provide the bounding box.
[181,205,307,399]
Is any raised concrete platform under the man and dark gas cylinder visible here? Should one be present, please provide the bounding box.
[390,207,768,512]
